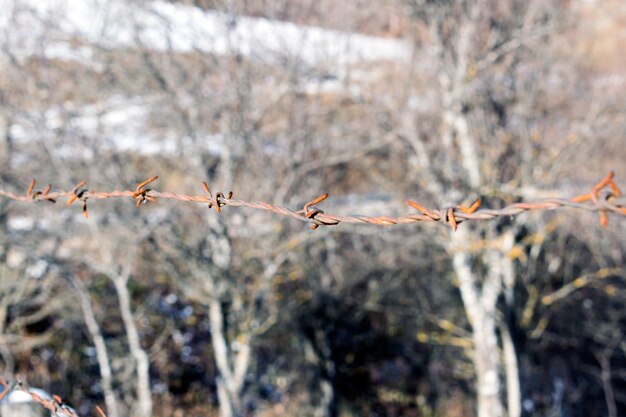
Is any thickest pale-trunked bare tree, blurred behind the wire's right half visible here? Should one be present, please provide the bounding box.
[394,1,588,416]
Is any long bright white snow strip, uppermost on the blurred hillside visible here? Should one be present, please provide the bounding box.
[6,0,411,69]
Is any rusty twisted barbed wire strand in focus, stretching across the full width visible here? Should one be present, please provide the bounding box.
[0,171,626,230]
